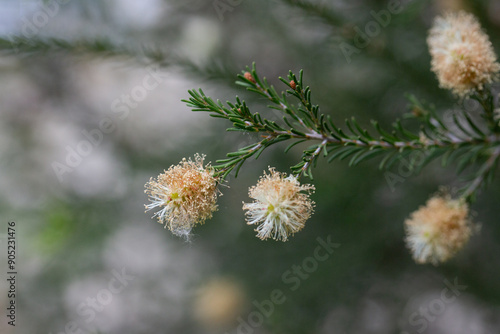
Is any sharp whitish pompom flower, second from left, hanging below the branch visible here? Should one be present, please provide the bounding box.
[243,168,314,241]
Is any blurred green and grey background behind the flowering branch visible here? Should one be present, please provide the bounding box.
[0,0,500,334]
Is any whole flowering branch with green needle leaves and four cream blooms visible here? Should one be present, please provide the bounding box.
[147,12,500,264]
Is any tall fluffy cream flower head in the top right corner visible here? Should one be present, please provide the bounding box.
[427,12,500,97]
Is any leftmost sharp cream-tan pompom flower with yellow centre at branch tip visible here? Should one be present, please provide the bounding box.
[145,154,219,237]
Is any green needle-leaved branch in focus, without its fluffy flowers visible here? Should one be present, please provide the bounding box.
[183,64,500,200]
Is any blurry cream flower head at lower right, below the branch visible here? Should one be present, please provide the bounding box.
[405,196,472,265]
